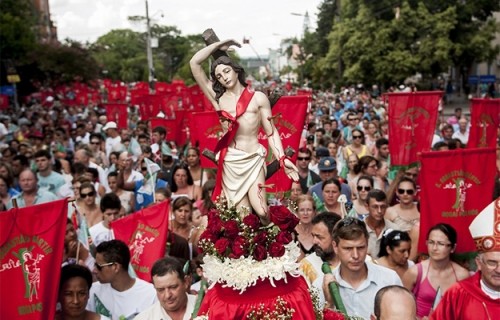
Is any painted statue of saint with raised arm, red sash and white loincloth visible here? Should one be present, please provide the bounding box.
[190,40,299,225]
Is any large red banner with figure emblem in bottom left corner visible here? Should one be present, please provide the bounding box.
[0,199,68,320]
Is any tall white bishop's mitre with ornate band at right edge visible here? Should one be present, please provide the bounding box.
[469,198,500,252]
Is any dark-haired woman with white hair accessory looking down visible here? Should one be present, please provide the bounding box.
[376,229,415,279]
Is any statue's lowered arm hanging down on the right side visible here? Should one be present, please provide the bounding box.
[254,92,299,181]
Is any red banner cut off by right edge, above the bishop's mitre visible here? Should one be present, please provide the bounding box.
[467,99,500,148]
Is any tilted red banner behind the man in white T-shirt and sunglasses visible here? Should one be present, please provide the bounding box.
[111,201,170,282]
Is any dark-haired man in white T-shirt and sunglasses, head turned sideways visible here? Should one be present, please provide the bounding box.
[87,240,157,320]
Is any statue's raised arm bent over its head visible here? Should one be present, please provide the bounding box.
[189,39,241,110]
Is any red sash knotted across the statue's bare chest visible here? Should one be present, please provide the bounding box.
[212,88,255,200]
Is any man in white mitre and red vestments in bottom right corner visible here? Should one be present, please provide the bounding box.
[430,198,500,320]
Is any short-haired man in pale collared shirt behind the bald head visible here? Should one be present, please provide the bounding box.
[323,217,402,319]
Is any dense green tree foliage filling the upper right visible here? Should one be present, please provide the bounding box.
[301,0,500,87]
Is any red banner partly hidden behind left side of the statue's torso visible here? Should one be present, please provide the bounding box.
[189,111,223,168]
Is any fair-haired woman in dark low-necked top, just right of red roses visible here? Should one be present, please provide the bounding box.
[295,194,316,261]
